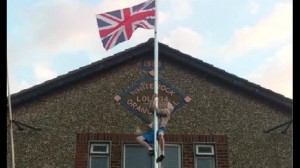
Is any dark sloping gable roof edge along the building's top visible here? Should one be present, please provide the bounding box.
[11,38,293,112]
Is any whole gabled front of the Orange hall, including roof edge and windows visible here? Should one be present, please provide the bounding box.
[7,39,293,168]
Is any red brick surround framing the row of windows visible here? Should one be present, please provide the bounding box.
[75,133,229,168]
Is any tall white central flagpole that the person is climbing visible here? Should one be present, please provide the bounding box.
[153,0,158,168]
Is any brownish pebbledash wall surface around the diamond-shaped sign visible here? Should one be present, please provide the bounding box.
[7,47,293,168]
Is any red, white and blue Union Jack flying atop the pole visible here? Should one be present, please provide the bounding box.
[96,0,155,50]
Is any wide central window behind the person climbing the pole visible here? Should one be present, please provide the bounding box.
[123,144,181,168]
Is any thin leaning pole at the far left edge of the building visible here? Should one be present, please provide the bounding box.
[6,68,15,168]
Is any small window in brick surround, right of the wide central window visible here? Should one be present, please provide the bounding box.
[195,144,216,168]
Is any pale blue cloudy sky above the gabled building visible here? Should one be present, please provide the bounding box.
[7,0,293,99]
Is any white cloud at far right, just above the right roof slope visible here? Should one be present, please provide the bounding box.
[247,43,293,98]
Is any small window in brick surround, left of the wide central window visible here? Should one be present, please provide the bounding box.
[89,142,110,168]
